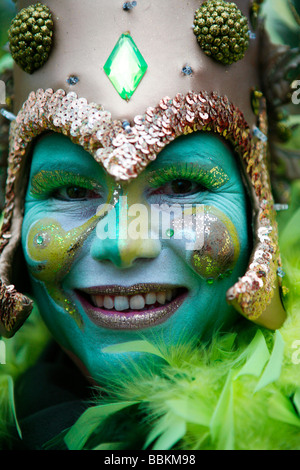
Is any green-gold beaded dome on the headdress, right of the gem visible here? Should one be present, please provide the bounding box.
[194,0,249,65]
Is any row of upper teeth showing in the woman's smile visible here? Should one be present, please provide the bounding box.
[91,289,176,312]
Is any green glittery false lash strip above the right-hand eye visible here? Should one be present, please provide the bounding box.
[148,163,229,189]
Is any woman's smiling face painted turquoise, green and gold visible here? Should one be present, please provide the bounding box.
[22,133,251,381]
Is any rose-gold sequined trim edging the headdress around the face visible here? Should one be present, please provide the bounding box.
[0,89,280,338]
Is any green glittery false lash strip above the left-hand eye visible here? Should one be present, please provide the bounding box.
[30,170,99,199]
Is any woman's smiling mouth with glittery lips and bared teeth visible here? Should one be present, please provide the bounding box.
[76,284,188,330]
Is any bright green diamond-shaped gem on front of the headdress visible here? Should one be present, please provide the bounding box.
[104,34,148,101]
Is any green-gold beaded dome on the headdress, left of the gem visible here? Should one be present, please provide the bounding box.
[8,3,53,74]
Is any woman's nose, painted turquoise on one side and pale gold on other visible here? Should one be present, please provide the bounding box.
[91,201,161,268]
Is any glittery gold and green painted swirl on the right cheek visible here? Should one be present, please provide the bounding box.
[174,206,240,284]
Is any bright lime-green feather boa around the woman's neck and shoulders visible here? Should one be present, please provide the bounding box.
[0,203,300,450]
